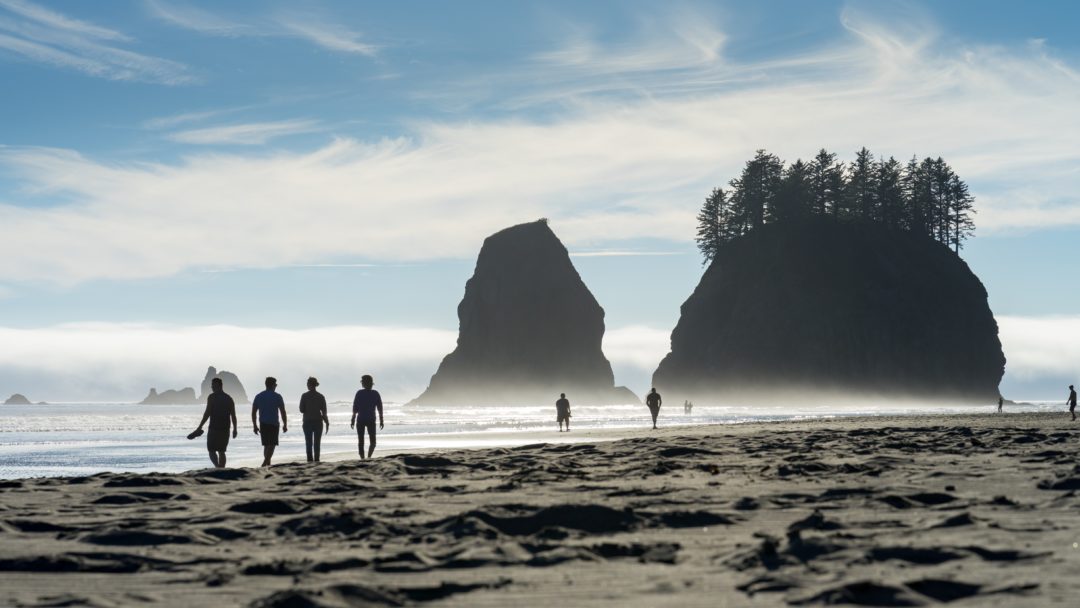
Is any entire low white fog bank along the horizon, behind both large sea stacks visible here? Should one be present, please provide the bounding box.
[0,316,1080,402]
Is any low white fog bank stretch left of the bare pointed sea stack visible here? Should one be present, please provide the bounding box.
[0,323,457,401]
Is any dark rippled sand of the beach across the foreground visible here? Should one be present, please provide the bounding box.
[0,414,1080,607]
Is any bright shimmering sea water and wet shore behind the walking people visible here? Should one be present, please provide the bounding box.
[0,402,1067,478]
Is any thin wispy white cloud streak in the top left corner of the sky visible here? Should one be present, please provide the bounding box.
[0,0,198,85]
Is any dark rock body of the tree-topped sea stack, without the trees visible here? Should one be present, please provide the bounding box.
[653,217,1005,405]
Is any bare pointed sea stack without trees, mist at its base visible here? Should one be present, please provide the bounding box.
[411,220,638,405]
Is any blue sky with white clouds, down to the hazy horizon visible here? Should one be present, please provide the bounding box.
[0,0,1080,401]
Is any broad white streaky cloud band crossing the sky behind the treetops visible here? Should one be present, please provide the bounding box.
[0,12,1080,284]
